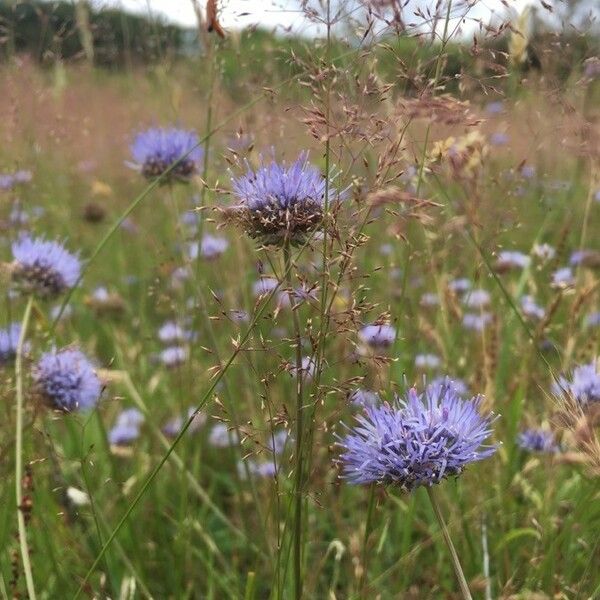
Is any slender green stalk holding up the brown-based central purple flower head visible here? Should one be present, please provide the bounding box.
[283,242,304,600]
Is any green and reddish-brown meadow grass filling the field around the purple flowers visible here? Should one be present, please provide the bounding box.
[0,5,600,600]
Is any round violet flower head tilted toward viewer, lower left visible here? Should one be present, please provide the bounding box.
[33,348,102,412]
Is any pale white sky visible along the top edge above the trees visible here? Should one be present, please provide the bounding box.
[86,0,531,33]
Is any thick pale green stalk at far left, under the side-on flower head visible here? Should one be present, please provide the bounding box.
[15,296,36,600]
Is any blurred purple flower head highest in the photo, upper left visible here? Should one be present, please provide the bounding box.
[131,127,204,183]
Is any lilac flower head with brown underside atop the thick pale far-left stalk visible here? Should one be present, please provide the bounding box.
[12,235,81,298]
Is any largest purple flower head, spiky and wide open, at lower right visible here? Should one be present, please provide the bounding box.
[338,386,496,491]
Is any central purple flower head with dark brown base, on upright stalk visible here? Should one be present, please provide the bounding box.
[232,153,342,246]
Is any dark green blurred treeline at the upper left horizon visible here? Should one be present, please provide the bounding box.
[0,0,194,67]
